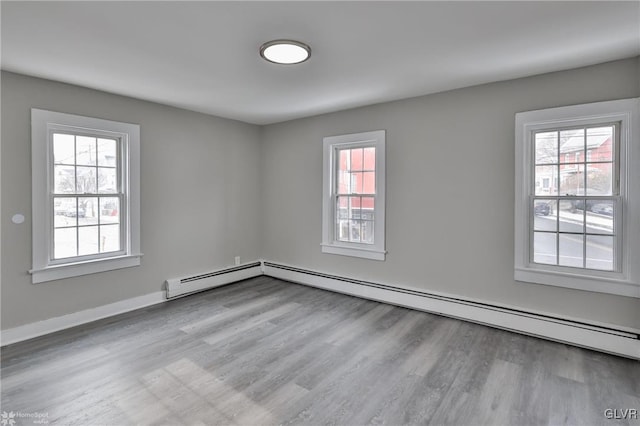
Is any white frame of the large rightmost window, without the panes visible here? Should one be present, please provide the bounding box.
[514,98,640,298]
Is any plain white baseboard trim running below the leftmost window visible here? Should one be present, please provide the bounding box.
[0,291,167,346]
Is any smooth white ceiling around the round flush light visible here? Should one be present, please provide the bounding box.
[1,1,640,124]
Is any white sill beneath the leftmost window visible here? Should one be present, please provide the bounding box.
[29,253,142,284]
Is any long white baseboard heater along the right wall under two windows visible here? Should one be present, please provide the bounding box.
[263,262,640,359]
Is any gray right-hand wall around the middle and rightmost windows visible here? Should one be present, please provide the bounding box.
[260,58,640,327]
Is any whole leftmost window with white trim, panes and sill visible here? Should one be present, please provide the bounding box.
[30,109,141,283]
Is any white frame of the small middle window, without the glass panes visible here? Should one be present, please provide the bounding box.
[321,130,387,260]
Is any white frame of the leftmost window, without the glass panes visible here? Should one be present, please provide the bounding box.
[29,108,142,284]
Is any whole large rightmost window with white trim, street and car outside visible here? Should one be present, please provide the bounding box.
[515,99,640,297]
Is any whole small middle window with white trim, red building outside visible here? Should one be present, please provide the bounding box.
[322,130,386,260]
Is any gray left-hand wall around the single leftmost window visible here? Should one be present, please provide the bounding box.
[1,72,260,329]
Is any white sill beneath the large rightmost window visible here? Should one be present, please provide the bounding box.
[514,268,640,298]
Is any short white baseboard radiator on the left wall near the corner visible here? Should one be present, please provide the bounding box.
[165,262,262,299]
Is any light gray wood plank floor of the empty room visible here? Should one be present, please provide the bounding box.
[1,277,640,426]
